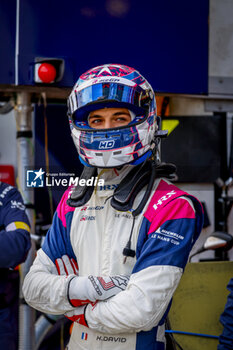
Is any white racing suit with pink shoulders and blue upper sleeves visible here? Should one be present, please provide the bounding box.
[23,166,203,350]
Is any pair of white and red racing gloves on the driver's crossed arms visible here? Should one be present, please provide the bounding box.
[55,255,129,307]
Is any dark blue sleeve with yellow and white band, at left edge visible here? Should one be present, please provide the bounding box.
[0,183,31,268]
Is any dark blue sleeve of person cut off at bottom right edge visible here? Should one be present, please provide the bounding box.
[218,278,233,350]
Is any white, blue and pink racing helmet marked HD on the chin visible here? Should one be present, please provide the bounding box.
[68,64,158,168]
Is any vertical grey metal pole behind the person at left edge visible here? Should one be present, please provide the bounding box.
[15,92,35,350]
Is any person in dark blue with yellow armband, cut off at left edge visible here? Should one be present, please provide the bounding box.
[0,182,31,350]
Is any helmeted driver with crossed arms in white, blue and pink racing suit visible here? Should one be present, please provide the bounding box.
[23,64,203,350]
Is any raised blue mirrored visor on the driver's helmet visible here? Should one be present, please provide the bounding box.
[70,83,151,121]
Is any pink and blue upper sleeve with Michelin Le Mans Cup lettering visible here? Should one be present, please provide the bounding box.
[133,199,202,273]
